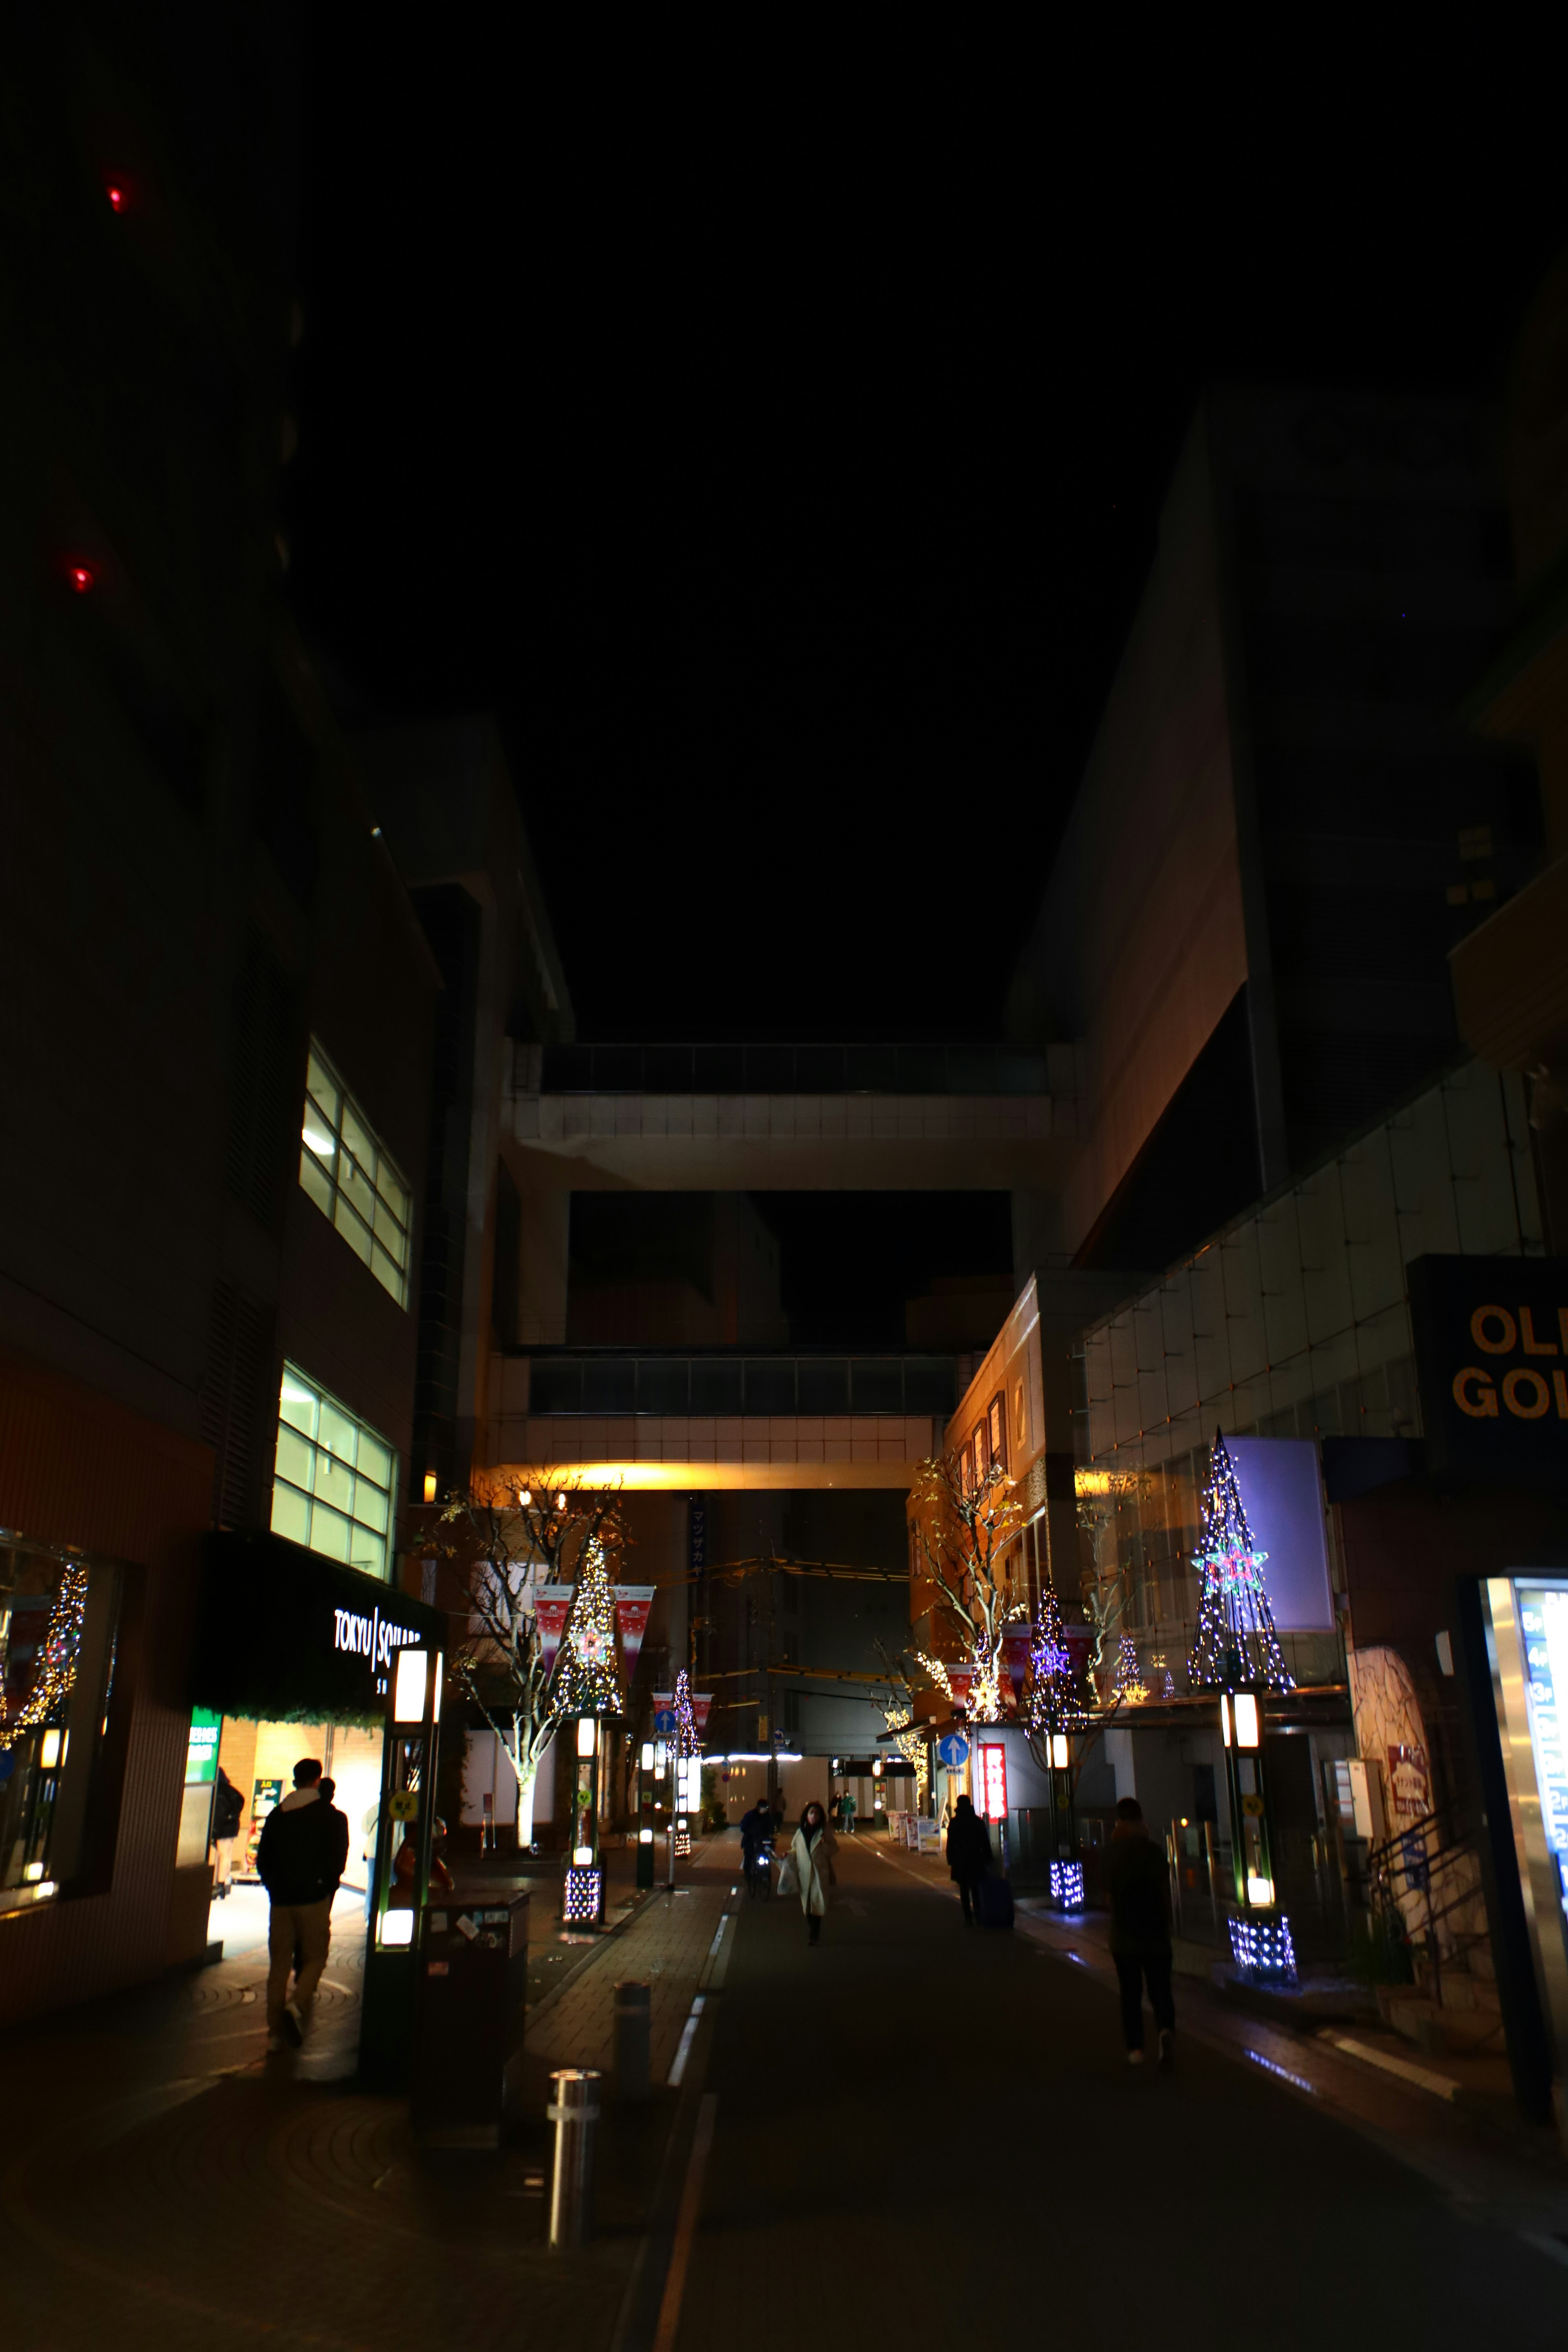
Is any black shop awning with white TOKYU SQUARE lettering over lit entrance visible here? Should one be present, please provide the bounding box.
[190,1531,449,1724]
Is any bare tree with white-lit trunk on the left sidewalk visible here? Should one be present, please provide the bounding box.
[440,1468,628,1849]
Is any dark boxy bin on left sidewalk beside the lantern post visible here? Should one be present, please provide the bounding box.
[409,1889,529,2147]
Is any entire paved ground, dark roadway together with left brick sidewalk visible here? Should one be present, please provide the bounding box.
[0,1837,1568,2352]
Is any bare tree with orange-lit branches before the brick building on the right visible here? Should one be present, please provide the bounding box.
[910,1454,1027,1724]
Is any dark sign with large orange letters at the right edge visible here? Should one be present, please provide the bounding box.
[1408,1258,1568,1489]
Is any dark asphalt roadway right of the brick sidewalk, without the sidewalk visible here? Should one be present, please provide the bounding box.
[677,1842,1568,2352]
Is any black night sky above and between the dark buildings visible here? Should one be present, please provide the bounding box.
[289,34,1568,1037]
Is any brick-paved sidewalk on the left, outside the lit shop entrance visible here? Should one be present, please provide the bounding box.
[0,1842,738,2352]
